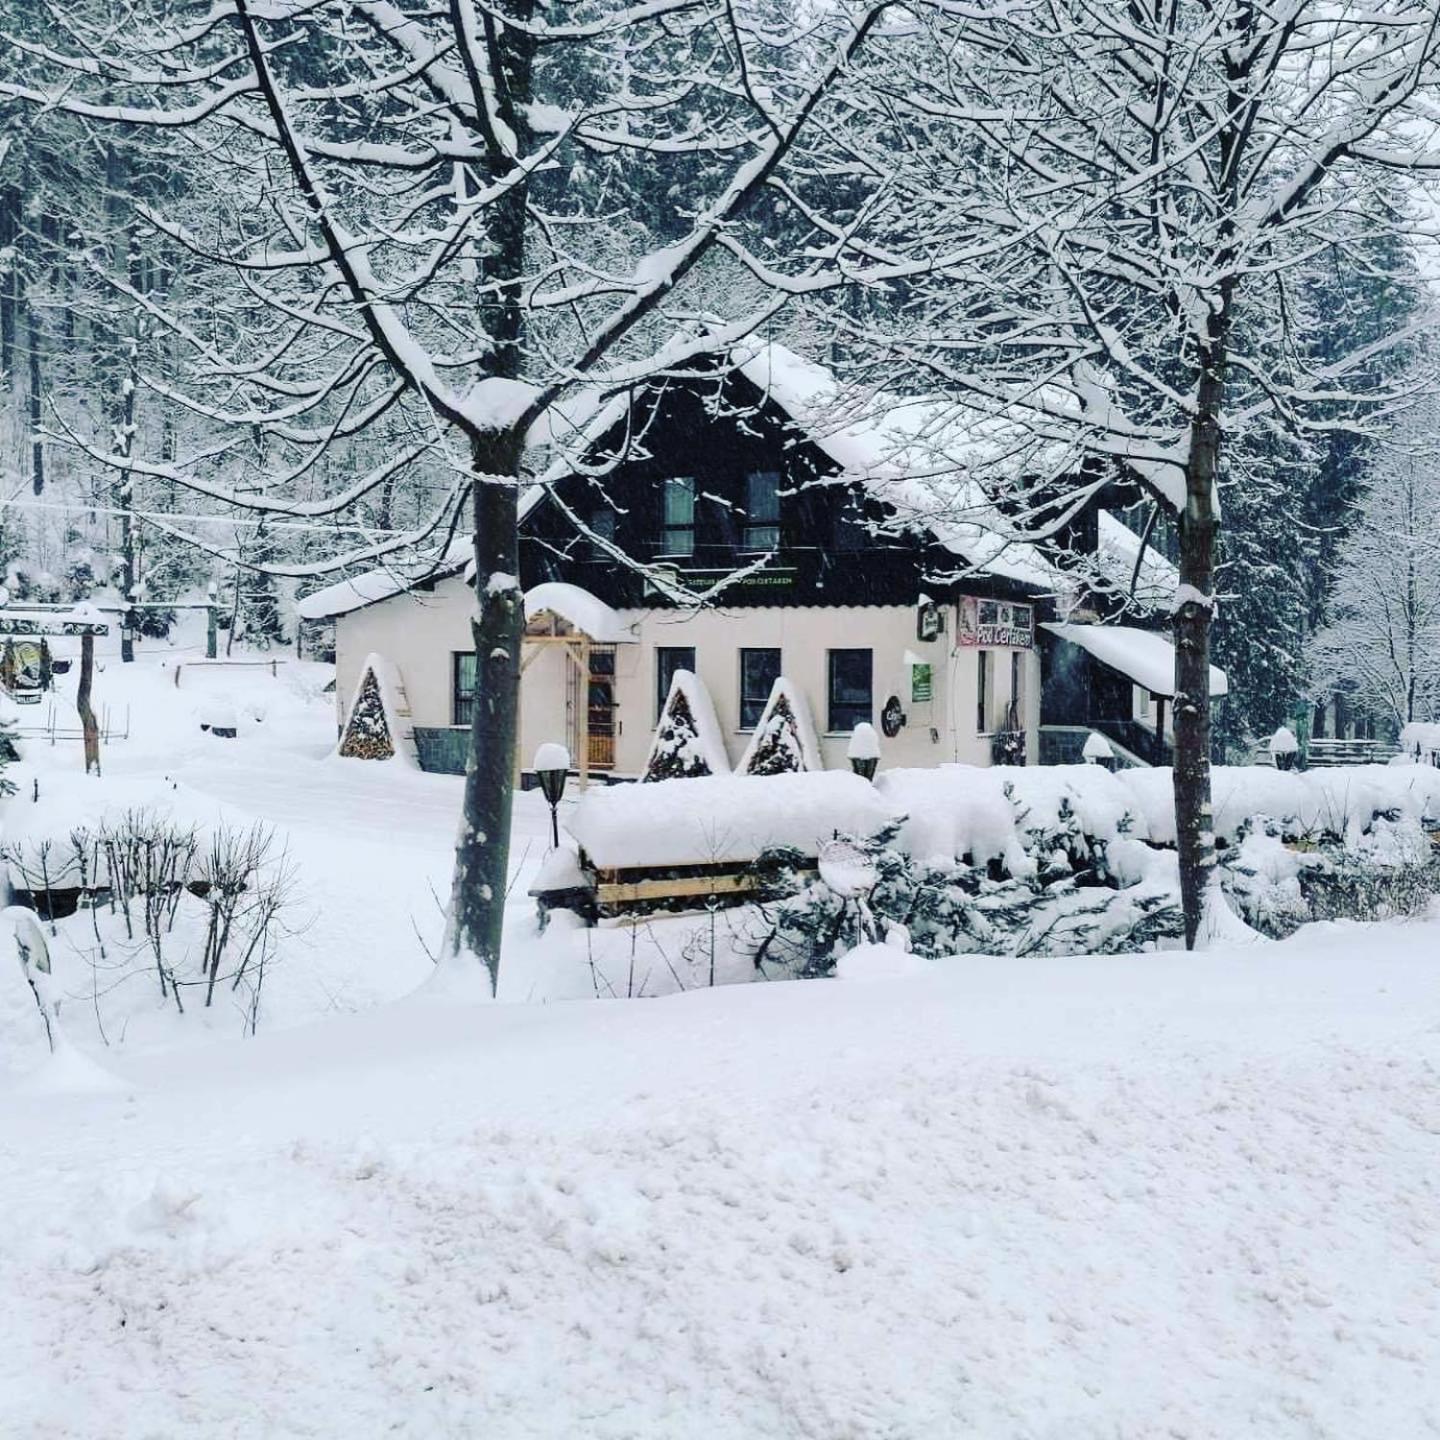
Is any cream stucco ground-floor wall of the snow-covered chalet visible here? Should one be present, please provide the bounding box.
[336,587,1040,773]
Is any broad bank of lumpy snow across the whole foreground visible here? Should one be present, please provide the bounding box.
[0,923,1440,1440]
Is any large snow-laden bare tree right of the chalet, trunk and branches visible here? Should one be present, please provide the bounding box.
[800,0,1440,945]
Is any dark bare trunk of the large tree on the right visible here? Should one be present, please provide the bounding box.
[1172,359,1224,950]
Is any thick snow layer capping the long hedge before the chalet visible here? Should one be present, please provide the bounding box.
[569,765,1440,883]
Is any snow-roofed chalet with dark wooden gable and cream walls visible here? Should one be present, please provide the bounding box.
[300,344,1224,779]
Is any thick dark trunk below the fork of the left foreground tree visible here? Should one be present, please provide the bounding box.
[444,432,524,992]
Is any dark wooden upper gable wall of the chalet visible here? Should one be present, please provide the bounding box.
[520,365,1048,609]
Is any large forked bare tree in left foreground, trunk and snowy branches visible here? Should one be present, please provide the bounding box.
[0,0,888,985]
